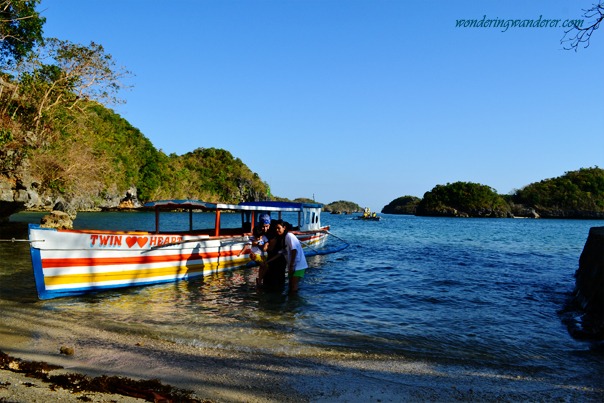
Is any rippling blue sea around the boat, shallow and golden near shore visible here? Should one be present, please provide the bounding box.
[0,213,604,385]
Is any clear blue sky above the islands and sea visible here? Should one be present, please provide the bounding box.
[38,0,604,211]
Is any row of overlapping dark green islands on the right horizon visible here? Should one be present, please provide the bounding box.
[382,167,604,223]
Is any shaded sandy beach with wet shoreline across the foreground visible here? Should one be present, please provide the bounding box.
[0,298,604,403]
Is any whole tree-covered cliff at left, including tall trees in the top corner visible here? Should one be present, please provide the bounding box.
[0,0,268,210]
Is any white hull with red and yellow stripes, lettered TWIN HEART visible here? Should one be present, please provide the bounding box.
[29,225,331,299]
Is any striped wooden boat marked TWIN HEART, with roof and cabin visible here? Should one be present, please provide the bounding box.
[29,200,348,299]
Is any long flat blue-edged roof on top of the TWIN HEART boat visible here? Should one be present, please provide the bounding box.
[144,199,323,211]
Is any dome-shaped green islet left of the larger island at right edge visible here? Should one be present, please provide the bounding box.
[417,182,510,217]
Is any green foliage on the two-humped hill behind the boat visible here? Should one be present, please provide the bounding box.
[20,103,267,208]
